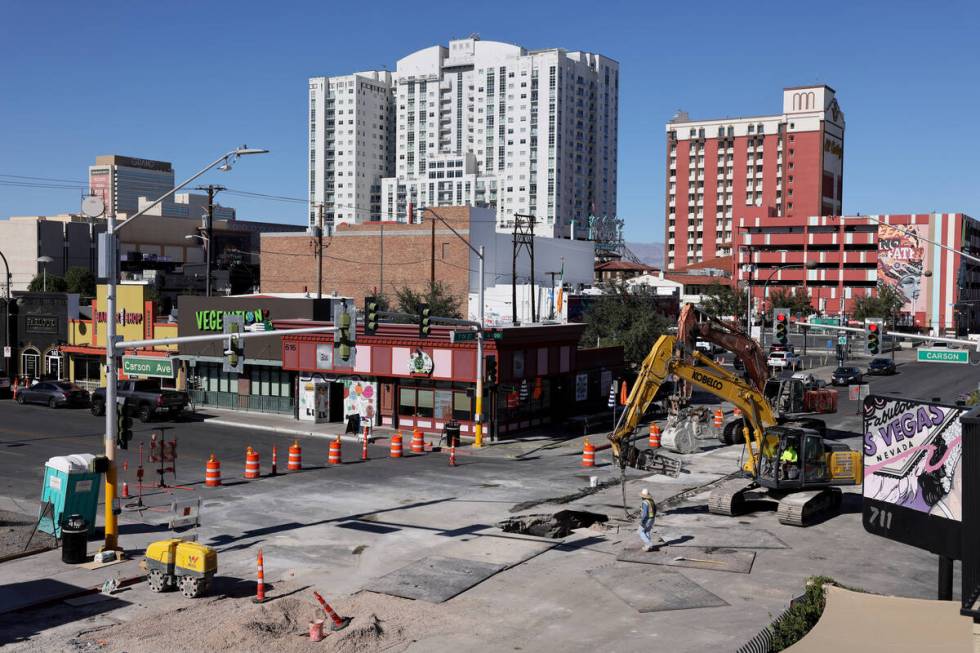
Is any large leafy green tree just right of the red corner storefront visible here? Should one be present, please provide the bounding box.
[579,286,671,367]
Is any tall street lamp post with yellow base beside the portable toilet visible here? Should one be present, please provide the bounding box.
[101,145,268,551]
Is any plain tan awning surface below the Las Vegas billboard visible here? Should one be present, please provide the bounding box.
[786,585,973,653]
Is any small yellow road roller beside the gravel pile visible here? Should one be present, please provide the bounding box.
[141,538,218,598]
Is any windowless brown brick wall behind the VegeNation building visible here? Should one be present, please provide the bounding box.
[260,207,470,315]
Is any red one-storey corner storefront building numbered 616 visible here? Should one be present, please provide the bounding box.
[276,321,623,436]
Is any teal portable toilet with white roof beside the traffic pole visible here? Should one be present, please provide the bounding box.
[38,453,102,538]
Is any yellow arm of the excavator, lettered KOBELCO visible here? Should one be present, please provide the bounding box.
[609,335,777,473]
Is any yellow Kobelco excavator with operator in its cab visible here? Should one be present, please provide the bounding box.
[609,335,862,526]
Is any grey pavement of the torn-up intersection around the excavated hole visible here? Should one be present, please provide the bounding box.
[0,352,980,651]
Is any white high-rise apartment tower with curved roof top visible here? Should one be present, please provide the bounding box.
[310,37,619,238]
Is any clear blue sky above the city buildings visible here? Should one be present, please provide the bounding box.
[0,0,980,241]
